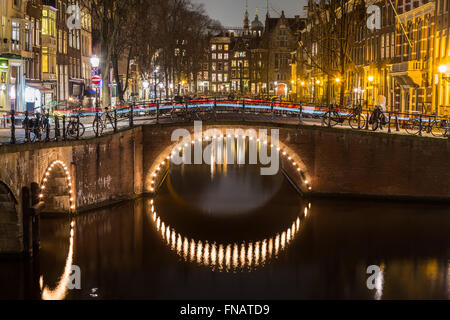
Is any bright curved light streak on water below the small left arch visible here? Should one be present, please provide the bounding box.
[41,220,75,300]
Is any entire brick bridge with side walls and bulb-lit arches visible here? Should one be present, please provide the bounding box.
[0,122,450,254]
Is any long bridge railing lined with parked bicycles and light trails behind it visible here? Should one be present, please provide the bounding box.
[0,98,450,144]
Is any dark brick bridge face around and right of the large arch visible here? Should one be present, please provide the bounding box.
[143,122,450,201]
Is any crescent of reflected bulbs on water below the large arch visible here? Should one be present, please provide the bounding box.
[149,199,310,272]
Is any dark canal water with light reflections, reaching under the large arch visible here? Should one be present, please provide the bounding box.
[0,156,450,300]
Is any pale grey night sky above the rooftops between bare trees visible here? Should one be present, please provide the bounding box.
[192,0,307,27]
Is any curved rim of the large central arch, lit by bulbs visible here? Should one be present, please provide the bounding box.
[144,128,313,194]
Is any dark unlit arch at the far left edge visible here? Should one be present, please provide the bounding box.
[0,181,21,253]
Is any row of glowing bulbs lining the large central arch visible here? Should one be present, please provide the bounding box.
[150,134,312,192]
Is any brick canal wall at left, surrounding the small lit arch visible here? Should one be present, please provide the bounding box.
[0,128,143,254]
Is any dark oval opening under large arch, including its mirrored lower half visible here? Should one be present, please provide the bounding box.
[150,131,308,242]
